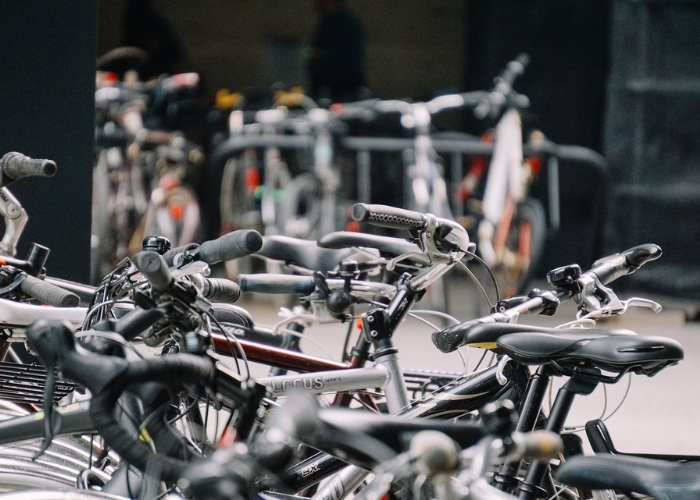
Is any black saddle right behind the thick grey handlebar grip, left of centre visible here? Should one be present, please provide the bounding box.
[257,235,353,273]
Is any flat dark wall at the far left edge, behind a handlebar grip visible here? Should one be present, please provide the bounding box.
[0,0,97,282]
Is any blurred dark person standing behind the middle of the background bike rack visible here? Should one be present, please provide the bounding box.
[308,0,366,102]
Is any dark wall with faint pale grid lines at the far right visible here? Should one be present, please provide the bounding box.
[605,0,700,298]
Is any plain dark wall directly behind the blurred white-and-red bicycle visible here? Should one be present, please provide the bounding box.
[465,0,610,270]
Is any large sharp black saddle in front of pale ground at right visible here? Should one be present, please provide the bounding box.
[497,329,683,376]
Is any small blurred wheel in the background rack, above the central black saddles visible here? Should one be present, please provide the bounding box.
[279,173,324,239]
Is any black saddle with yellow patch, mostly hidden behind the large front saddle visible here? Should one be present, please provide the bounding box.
[443,323,636,349]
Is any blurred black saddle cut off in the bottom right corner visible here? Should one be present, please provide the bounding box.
[556,455,700,500]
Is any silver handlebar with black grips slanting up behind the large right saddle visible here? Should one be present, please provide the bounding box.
[431,243,661,353]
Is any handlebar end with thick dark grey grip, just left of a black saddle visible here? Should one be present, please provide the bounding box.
[163,229,262,266]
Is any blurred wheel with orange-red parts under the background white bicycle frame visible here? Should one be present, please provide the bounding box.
[494,198,547,296]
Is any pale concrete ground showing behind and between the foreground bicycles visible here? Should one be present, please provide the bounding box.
[241,284,700,455]
